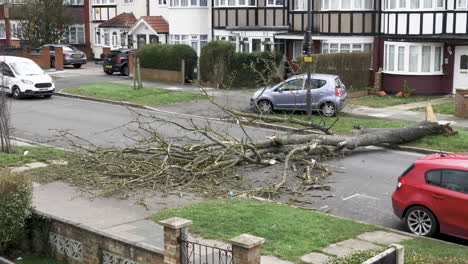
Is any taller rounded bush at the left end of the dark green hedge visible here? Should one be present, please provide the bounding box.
[200,40,236,85]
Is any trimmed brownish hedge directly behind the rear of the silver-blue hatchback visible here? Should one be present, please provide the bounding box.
[297,52,372,90]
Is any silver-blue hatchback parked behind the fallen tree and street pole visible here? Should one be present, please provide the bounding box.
[250,74,348,116]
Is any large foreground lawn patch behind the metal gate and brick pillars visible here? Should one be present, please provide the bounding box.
[151,199,379,261]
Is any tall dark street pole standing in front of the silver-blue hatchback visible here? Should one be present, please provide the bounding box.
[304,0,313,120]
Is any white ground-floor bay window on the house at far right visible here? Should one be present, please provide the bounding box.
[384,41,444,75]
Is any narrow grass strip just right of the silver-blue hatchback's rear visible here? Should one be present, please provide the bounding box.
[346,95,439,108]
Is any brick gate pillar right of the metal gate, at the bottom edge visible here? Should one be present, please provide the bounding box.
[229,234,265,264]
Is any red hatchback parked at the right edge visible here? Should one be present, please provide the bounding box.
[392,154,468,239]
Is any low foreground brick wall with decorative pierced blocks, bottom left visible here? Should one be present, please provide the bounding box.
[33,213,164,264]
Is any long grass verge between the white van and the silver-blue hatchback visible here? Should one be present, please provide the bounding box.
[64,83,206,105]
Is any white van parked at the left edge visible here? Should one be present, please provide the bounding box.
[0,56,55,98]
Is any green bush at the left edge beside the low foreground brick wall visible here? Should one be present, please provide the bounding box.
[0,170,32,252]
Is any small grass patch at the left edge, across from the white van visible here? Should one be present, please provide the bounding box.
[0,146,67,168]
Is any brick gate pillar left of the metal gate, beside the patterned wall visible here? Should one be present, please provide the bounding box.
[158,217,192,264]
